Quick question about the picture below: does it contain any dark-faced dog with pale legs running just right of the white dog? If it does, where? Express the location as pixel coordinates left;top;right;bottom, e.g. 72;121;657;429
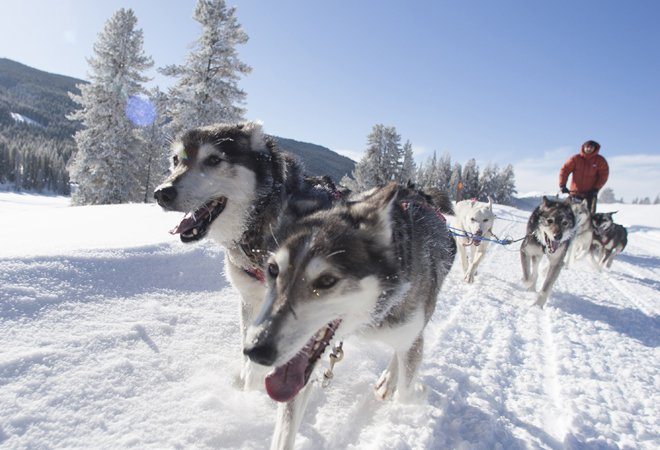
520;196;575;308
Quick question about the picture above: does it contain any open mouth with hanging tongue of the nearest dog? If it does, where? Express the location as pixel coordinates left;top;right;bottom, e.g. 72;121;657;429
266;320;341;402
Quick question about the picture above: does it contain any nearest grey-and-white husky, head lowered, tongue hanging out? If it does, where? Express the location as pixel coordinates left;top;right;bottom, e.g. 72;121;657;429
244;183;456;448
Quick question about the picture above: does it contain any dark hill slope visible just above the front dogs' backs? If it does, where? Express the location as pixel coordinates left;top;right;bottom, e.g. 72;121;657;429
273;136;355;182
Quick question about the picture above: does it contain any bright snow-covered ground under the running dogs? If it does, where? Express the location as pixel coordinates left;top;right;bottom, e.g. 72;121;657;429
0;193;660;449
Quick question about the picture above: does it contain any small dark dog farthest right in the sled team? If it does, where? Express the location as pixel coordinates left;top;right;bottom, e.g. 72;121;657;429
591;211;628;270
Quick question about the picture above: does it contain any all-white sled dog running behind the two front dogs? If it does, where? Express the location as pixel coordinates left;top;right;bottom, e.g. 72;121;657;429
454;197;495;283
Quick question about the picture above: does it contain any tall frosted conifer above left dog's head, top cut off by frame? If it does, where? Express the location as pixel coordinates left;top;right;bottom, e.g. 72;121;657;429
160;0;252;135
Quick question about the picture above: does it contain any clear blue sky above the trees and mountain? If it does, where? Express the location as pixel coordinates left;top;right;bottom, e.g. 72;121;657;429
0;0;660;201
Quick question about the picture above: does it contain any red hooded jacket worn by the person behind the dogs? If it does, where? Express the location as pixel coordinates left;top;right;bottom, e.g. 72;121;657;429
559;144;610;194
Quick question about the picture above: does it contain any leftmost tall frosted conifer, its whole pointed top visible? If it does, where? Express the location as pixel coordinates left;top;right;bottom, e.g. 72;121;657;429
68;8;153;205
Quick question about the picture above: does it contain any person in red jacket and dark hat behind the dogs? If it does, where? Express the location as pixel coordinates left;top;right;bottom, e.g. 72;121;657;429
559;141;610;214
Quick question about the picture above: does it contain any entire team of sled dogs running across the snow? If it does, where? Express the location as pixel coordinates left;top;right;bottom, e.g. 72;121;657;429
154;122;627;449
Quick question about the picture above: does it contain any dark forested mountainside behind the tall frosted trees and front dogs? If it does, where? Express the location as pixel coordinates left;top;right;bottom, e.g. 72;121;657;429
0;58;355;195
